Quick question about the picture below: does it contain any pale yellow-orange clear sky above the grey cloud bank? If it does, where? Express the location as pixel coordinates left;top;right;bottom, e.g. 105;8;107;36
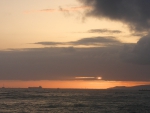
0;0;139;50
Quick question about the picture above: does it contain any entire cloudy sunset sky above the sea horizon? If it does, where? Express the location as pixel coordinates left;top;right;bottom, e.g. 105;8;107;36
0;0;150;89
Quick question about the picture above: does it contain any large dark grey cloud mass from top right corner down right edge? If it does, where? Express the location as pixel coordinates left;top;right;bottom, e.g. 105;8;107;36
79;0;150;65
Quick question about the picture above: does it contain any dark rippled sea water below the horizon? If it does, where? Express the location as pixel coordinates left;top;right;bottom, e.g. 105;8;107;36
0;89;150;113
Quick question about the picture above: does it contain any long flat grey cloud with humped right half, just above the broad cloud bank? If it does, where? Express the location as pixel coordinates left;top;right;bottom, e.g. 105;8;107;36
35;37;121;46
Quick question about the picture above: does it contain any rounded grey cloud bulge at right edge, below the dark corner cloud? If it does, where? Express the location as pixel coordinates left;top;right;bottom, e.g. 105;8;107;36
122;35;150;65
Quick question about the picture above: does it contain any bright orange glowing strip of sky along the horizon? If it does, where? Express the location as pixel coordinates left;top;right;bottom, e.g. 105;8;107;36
0;80;150;89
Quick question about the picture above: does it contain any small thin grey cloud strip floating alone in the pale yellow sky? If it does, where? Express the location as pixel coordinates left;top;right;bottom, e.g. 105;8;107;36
88;29;122;34
